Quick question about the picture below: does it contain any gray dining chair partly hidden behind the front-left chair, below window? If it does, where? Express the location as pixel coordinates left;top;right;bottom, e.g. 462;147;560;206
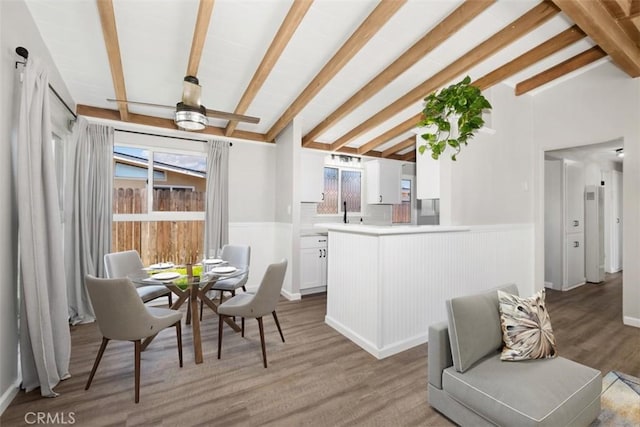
104;250;173;307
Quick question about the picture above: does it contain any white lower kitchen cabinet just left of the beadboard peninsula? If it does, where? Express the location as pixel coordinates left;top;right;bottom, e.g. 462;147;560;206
300;236;327;295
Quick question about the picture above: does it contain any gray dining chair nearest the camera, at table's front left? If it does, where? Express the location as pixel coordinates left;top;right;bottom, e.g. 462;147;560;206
84;275;182;403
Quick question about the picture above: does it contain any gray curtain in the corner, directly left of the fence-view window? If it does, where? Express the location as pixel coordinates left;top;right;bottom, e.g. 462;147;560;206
65;117;113;324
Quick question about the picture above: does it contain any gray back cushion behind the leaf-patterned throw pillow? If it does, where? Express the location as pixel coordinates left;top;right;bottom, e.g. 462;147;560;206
447;284;518;372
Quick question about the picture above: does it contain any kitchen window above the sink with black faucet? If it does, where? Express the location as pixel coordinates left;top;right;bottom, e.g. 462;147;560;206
317;167;362;214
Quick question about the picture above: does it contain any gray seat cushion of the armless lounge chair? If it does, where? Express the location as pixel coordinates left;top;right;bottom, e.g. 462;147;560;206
442;354;602;426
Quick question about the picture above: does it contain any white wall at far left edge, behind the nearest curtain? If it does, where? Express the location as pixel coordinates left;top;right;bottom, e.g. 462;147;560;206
0;0;73;413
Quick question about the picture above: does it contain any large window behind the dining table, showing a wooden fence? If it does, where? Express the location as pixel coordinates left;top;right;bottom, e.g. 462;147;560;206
112;145;207;265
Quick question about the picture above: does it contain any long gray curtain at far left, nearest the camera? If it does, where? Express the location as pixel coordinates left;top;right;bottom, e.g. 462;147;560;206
16;58;71;397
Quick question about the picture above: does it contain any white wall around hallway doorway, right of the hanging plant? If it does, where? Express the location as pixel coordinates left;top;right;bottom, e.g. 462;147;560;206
440;62;640;327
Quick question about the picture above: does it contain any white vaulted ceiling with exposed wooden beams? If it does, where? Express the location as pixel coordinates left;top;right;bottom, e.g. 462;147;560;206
25;0;640;161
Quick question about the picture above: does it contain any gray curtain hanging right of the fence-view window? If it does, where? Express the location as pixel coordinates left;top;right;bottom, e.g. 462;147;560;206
204;141;231;256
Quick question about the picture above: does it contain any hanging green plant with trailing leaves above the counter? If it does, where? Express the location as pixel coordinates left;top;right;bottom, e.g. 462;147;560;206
418;76;491;161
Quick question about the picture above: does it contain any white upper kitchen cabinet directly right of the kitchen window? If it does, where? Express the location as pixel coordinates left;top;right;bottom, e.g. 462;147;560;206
364;160;402;205
